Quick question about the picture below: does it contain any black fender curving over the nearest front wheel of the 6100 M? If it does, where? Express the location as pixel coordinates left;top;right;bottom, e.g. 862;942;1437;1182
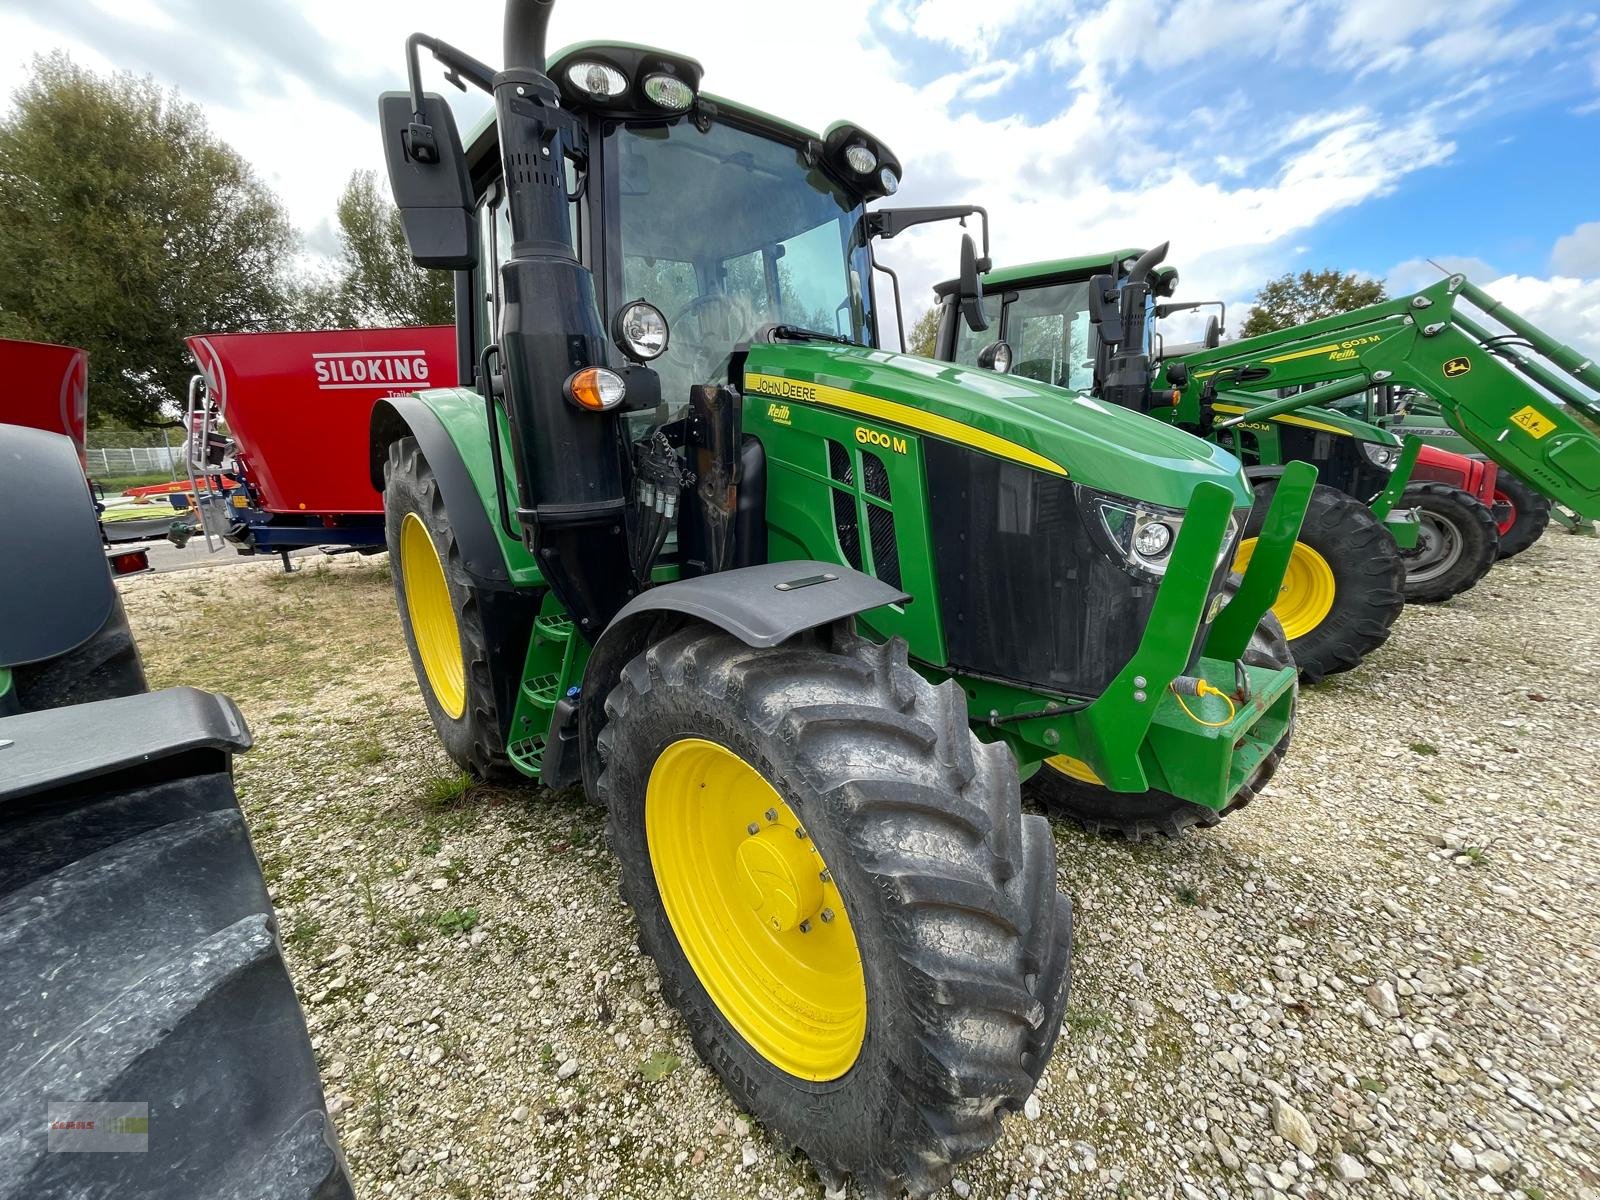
569;560;910;797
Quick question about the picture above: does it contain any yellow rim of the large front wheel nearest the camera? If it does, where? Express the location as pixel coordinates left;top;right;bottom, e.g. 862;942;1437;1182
645;738;867;1082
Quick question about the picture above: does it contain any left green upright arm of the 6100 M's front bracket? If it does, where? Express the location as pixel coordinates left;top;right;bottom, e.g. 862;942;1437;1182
1077;480;1235;792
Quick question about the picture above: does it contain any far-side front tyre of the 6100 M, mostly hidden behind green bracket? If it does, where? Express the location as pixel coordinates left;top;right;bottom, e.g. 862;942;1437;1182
1024;613;1294;842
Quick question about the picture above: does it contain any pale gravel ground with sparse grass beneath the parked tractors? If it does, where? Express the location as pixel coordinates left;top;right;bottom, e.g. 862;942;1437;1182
125;531;1600;1200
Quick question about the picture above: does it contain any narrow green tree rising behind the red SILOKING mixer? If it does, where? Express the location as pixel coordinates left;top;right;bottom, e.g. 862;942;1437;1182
294;171;456;326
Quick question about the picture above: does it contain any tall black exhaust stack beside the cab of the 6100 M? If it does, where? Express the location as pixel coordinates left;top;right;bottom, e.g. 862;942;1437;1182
494;0;634;637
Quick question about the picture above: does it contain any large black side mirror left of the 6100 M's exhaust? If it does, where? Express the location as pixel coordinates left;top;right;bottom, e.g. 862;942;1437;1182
378;91;478;270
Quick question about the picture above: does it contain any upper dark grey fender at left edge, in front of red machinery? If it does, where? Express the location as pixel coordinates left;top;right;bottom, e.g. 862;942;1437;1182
0;426;117;667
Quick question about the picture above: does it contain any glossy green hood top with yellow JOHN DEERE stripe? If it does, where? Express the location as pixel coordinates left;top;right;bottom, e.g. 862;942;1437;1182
744;342;1253;509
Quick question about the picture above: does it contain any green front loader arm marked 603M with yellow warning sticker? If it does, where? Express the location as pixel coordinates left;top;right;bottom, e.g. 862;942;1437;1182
1163;275;1600;518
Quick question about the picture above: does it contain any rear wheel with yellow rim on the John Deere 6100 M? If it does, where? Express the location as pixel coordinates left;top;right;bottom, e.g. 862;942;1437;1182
384;437;518;781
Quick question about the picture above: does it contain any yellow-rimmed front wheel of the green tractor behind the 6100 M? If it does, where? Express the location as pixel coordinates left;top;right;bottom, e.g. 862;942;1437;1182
1234;480;1405;683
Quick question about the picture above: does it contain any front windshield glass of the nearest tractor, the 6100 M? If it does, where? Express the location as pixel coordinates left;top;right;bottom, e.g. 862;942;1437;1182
618;120;872;405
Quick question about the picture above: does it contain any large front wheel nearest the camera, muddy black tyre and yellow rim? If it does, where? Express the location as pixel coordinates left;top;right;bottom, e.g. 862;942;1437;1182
597;626;1072;1197
